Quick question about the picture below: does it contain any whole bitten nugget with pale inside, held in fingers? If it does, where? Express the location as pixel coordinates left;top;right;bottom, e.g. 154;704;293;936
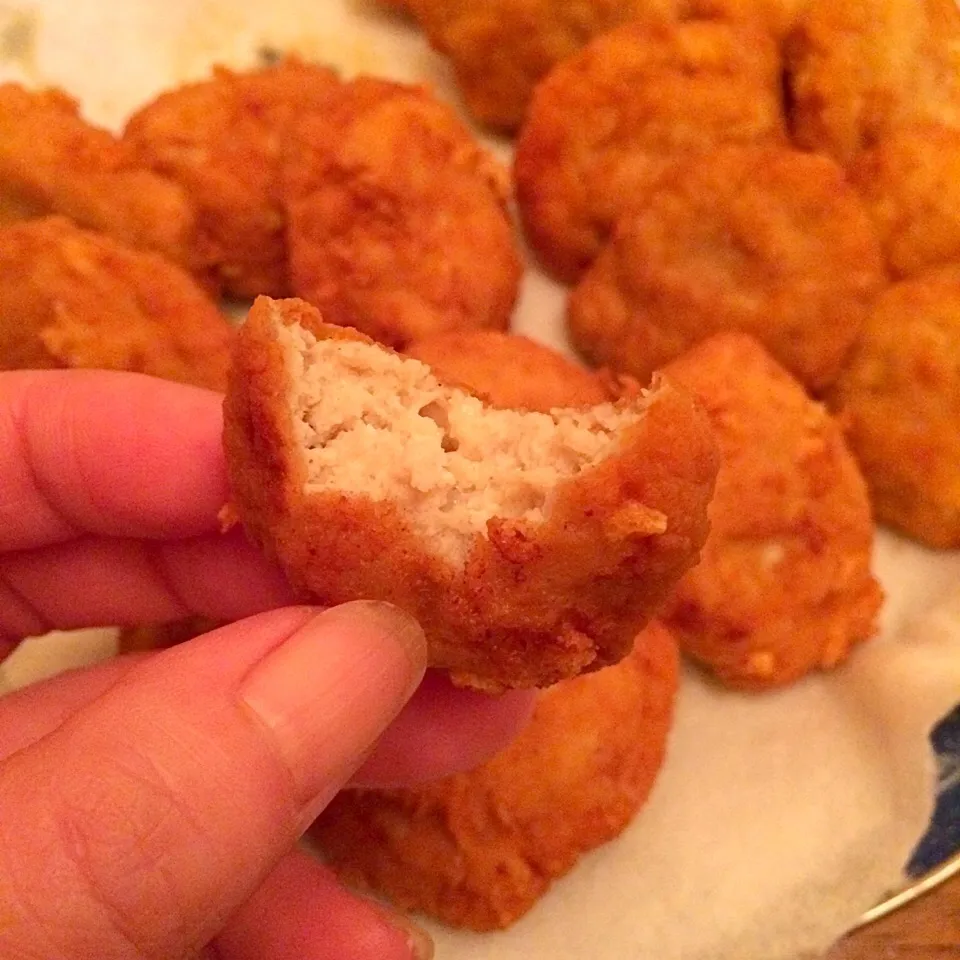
225;298;717;690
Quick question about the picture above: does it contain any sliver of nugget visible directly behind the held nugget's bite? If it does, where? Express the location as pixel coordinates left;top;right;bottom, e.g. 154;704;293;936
405;330;611;413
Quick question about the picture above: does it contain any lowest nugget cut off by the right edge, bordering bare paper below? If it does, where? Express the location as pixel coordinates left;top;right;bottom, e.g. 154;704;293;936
830;265;960;549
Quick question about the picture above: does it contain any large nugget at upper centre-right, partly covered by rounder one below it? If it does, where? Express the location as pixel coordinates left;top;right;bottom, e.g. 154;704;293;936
514;21;784;280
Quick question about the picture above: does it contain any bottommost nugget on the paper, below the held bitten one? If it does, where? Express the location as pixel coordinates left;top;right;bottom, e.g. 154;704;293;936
310;622;678;930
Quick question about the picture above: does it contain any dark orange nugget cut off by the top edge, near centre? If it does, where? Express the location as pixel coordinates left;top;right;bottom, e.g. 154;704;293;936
407;0;680;132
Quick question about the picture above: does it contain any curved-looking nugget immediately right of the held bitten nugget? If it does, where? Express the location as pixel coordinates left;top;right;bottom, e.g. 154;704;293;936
663;333;882;689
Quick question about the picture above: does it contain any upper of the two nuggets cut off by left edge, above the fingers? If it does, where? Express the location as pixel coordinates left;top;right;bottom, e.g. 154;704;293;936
0;83;194;262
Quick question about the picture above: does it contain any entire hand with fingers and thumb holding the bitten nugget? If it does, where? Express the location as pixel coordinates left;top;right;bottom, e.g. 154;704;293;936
0;371;530;960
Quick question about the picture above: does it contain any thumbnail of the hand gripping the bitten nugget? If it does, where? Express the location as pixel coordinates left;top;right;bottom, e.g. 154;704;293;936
240;601;427;827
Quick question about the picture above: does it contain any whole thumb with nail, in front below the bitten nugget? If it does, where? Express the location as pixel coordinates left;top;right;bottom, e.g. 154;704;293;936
0;603;426;960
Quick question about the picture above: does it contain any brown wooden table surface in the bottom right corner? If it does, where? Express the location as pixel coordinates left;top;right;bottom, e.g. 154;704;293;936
826;875;960;960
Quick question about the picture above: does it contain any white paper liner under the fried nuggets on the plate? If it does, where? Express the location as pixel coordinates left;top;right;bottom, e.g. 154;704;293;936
0;0;960;960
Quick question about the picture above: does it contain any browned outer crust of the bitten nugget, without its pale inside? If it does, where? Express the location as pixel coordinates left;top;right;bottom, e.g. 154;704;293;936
225;298;717;690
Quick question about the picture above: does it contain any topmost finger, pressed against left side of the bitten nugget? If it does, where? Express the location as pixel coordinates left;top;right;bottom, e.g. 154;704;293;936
0;370;228;551
